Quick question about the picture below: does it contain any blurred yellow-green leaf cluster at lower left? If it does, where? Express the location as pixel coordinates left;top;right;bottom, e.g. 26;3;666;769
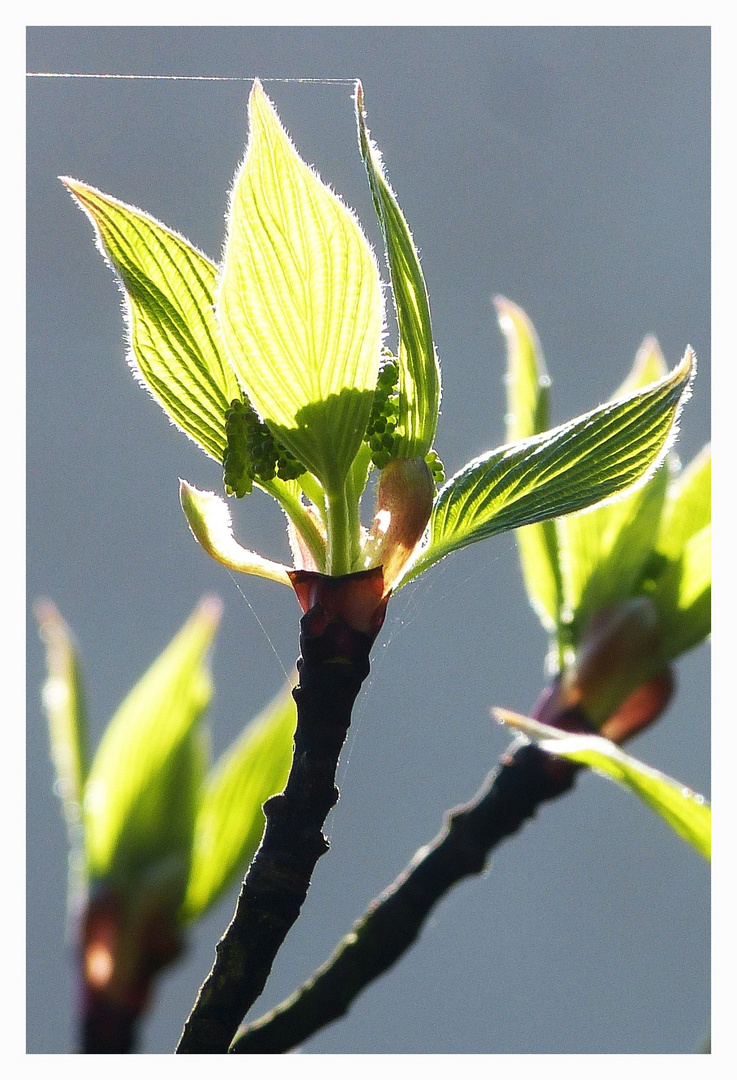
37;598;296;926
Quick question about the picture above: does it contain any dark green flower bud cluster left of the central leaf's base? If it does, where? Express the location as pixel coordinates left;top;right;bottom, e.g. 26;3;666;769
223;399;306;499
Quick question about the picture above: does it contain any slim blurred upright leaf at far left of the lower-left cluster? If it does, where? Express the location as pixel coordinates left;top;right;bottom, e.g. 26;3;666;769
36;600;88;843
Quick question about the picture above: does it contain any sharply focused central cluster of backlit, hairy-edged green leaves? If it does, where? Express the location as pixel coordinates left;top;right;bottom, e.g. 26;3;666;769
65;82;694;596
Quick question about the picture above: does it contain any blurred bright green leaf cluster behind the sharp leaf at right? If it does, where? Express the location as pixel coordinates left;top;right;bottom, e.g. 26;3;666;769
496;298;711;672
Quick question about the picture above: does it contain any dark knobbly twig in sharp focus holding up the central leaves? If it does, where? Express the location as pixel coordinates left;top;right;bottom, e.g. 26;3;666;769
176;571;386;1054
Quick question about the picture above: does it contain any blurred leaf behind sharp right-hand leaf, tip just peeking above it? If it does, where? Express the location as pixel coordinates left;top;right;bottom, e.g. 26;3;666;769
555;337;673;639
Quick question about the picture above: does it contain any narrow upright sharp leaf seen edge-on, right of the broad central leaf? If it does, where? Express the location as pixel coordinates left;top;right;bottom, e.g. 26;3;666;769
356;82;440;458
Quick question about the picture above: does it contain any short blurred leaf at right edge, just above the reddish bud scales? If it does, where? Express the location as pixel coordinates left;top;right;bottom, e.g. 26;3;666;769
651;525;711;660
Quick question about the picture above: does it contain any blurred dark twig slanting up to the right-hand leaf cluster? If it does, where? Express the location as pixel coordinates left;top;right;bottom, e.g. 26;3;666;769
230;730;585;1054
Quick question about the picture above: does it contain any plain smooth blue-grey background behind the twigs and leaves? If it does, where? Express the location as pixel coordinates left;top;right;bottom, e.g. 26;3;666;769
27;26;711;1054
